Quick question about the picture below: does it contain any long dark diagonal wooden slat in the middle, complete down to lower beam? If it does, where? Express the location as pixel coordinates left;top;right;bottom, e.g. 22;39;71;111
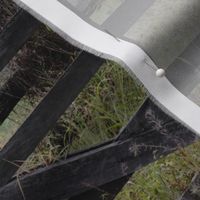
0;52;103;186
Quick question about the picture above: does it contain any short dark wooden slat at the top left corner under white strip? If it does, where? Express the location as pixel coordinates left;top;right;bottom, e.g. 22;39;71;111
0;10;40;71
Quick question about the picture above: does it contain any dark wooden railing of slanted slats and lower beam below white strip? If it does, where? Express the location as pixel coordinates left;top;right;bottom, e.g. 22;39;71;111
0;10;199;200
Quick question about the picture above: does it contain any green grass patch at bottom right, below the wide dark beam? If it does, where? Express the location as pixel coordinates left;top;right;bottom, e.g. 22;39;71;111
117;143;200;200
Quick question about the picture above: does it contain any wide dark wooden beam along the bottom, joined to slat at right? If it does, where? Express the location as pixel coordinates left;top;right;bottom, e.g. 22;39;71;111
0;100;198;200
